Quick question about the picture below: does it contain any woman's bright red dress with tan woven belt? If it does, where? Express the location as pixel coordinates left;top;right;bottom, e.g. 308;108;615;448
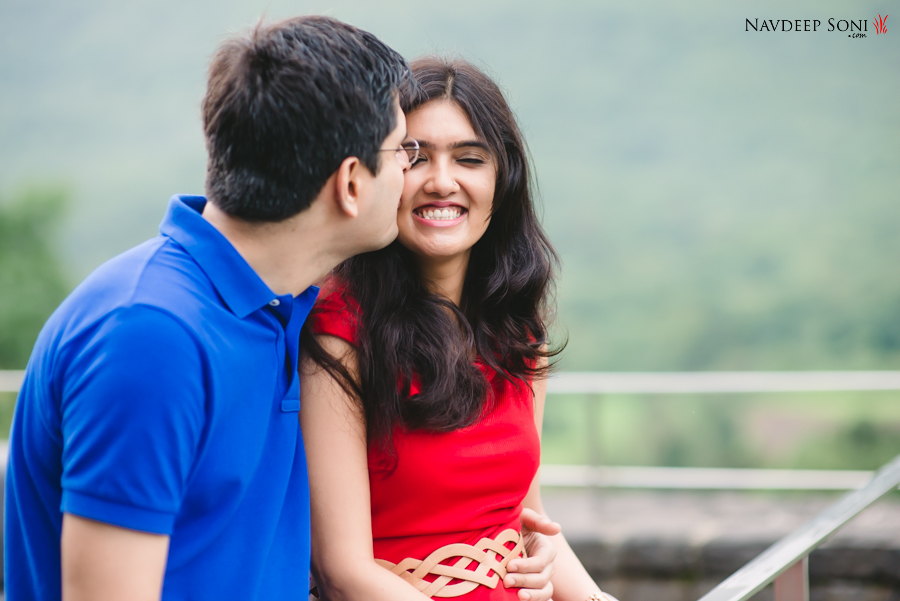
310;292;540;601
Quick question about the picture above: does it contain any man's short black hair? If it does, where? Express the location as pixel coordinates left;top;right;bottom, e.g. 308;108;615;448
203;16;410;222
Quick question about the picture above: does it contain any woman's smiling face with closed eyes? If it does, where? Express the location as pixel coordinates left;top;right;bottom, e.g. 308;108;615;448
397;99;497;270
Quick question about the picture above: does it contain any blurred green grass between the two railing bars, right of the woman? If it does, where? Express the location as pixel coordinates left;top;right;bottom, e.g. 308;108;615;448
543;391;900;470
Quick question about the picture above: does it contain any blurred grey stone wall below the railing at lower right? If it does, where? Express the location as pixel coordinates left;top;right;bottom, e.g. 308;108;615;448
544;489;900;601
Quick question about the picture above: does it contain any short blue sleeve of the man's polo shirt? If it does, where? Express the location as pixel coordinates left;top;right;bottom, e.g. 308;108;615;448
60;305;206;534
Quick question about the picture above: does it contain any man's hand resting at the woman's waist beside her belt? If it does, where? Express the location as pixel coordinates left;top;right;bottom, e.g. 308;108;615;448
503;507;560;601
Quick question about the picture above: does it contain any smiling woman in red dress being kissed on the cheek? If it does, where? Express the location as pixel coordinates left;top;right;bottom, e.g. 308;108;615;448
301;58;620;601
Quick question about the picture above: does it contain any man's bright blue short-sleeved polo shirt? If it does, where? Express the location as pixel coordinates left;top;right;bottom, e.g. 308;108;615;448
4;196;318;601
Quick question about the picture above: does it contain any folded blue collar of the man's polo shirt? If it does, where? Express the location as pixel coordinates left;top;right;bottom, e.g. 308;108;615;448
159;195;277;319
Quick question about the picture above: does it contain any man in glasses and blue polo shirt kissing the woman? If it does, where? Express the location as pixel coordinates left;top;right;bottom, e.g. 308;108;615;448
4;17;552;601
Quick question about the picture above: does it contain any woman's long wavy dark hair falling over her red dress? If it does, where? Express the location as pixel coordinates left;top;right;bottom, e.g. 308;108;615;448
303;57;559;447
